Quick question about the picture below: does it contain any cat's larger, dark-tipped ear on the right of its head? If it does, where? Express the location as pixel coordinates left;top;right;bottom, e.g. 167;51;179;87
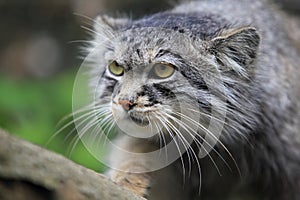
209;27;260;76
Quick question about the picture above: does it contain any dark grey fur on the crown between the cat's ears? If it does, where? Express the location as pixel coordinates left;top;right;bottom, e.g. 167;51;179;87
124;12;228;39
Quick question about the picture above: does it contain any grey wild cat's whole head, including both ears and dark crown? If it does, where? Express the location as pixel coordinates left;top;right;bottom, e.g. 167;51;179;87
85;13;259;143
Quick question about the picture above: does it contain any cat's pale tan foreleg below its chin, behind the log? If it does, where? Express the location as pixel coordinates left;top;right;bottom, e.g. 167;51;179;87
107;137;154;198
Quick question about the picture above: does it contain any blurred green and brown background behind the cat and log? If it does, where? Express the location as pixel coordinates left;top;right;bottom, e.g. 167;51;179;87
0;0;300;172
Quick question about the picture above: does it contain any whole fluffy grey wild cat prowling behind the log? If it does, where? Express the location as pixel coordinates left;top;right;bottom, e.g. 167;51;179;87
84;0;300;200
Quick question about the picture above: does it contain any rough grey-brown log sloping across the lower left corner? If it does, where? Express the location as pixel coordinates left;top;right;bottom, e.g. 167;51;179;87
0;130;141;200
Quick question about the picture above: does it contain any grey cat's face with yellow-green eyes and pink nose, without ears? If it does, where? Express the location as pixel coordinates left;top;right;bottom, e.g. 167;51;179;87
94;28;209;137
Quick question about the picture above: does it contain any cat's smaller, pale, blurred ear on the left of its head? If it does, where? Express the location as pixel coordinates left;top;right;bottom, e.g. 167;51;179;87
94;15;130;32
